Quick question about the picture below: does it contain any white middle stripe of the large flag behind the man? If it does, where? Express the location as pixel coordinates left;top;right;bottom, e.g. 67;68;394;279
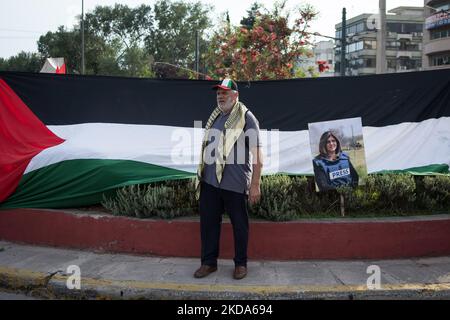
25;117;450;174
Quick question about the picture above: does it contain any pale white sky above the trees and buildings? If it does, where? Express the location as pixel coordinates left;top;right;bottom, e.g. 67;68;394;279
0;0;424;58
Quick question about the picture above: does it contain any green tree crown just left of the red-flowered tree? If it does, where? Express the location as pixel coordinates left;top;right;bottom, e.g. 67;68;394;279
146;0;211;75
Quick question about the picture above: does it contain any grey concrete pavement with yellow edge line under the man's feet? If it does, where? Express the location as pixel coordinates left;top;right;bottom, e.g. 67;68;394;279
0;241;450;299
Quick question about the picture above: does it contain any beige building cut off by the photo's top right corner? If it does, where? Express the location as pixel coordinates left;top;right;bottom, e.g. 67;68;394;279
422;0;450;69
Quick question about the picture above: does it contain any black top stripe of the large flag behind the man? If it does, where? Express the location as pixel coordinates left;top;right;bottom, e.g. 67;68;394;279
0;69;450;131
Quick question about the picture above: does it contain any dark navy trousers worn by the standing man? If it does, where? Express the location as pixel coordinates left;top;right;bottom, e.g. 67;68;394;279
200;182;248;266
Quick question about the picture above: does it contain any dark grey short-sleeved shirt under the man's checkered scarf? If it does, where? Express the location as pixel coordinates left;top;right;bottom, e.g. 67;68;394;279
202;111;261;193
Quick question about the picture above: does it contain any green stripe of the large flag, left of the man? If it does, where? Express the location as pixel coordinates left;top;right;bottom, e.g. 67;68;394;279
0;159;195;208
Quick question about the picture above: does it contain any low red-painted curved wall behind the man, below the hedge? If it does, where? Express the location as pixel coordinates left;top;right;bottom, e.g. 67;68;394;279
0;209;450;260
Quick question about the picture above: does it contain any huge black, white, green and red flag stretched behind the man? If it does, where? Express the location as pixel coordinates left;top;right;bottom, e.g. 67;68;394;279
0;70;450;208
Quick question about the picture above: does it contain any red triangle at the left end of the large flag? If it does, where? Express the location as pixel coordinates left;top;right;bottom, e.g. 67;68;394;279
0;78;64;202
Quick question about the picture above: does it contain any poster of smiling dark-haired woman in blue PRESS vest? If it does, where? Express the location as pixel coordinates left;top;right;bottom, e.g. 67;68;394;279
308;118;367;191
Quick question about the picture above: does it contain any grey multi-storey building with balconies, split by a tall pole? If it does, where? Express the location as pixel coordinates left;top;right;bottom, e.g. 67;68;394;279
335;7;424;75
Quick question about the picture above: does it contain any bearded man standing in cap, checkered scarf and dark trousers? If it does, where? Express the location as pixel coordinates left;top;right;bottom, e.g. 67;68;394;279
194;79;262;279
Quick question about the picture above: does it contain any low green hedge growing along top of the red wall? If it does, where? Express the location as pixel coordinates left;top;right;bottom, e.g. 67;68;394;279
102;174;450;221
